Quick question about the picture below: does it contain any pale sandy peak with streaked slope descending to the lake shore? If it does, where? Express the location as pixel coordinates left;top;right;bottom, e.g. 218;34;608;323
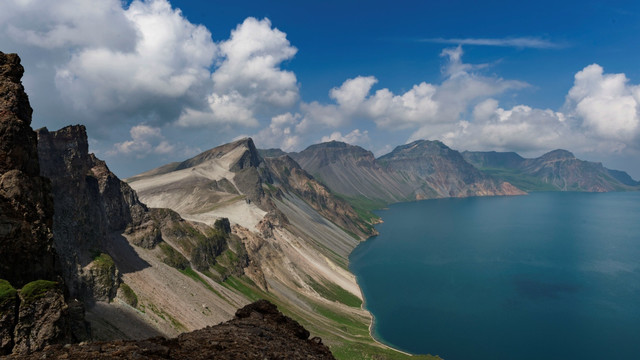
127;139;424;358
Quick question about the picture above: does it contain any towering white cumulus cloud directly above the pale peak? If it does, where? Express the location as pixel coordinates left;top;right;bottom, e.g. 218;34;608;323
178;18;299;126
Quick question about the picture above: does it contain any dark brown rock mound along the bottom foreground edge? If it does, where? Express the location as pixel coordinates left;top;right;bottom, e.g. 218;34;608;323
9;300;334;360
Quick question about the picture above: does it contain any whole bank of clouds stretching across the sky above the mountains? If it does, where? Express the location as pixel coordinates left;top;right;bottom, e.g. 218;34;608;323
0;0;640;177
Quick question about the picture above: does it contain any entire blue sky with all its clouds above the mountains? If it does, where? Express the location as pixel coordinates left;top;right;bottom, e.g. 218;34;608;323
0;0;640;179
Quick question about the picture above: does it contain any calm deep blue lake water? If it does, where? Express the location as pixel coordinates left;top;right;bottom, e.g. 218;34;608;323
351;193;640;360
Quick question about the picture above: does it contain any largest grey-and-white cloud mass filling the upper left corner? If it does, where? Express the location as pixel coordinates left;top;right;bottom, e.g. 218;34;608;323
0;0;217;129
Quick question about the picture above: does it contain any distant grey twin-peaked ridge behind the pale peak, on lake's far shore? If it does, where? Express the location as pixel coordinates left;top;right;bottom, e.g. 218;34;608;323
271;140;523;208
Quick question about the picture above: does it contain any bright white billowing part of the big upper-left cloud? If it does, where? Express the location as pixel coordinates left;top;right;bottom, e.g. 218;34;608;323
56;0;216;113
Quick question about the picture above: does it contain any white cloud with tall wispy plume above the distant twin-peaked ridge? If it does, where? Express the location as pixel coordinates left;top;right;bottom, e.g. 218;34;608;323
297;46;527;132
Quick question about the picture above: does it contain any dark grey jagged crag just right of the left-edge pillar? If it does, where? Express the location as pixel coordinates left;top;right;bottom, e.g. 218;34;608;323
37;125;148;300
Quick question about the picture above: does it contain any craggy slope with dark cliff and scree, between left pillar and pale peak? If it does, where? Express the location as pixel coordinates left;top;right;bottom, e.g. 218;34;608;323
37;125;249;339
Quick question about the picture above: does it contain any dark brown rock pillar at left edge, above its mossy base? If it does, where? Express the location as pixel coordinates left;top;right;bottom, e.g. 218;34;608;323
0;52;59;287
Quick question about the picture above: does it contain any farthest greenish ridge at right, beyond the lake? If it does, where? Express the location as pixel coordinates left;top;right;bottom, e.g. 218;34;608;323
463;150;640;192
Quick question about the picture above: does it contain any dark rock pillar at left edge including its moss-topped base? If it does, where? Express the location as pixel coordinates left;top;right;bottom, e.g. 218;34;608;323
0;52;75;355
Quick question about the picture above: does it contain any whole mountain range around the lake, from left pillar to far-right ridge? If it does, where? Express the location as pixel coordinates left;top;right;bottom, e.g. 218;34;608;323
0;53;640;359
